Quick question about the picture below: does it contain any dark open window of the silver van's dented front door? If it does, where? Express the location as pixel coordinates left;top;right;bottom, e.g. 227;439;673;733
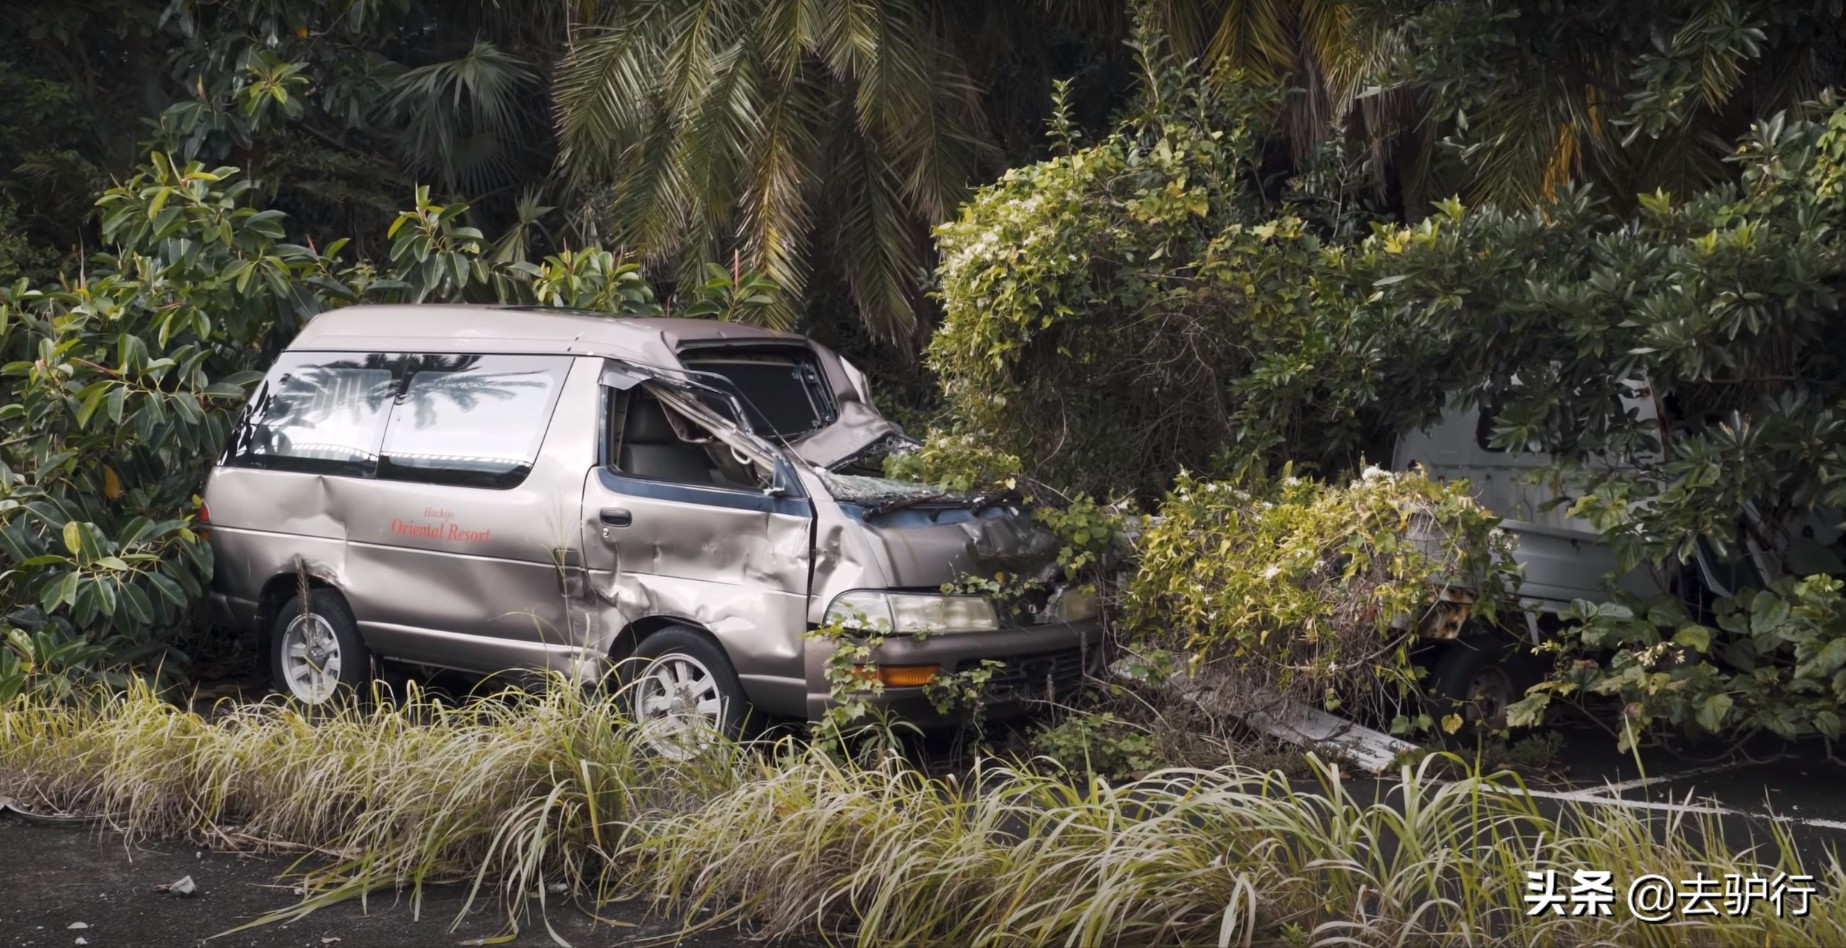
609;387;770;491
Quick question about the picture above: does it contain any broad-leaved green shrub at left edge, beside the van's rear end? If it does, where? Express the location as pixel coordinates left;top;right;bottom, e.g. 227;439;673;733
0;155;338;681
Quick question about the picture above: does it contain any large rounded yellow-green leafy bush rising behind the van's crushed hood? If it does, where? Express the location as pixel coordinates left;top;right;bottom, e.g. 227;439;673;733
929;53;1438;496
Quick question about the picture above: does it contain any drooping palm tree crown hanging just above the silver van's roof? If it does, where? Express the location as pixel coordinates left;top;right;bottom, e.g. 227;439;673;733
557;0;991;339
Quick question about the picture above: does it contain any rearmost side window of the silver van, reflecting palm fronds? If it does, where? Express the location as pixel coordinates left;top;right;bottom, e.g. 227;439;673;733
225;352;397;478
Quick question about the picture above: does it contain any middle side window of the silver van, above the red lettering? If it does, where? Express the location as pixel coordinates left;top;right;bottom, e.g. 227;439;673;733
378;354;570;489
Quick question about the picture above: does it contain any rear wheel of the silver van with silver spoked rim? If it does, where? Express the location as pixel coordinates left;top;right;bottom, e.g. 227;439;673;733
270;588;371;705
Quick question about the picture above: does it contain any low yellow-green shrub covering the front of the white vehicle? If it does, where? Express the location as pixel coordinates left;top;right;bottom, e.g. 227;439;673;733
1122;468;1514;714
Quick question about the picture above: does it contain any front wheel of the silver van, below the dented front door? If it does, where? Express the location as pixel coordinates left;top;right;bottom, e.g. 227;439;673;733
622;625;749;758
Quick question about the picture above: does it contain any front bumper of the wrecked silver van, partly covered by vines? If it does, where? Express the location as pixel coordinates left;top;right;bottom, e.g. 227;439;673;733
807;620;1104;727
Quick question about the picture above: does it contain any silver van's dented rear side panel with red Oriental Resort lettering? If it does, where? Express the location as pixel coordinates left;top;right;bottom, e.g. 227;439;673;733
205;360;600;671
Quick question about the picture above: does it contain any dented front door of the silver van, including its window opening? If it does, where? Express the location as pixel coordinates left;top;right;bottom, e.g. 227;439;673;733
583;378;814;714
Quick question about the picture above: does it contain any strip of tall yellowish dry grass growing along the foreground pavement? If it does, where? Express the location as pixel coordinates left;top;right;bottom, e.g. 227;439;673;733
0;686;1846;946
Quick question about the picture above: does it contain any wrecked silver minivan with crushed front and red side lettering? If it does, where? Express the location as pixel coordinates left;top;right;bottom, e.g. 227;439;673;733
205;304;1102;732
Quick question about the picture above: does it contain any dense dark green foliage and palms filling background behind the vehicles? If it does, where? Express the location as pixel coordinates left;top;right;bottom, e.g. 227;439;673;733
0;0;1846;748
